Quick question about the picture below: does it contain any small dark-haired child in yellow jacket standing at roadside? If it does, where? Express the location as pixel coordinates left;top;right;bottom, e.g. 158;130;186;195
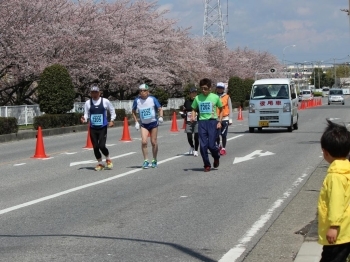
317;120;350;262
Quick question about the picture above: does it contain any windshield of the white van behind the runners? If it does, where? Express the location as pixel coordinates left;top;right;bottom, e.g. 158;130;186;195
251;84;289;100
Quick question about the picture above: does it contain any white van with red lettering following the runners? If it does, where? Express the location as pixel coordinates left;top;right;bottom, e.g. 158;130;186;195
248;78;299;133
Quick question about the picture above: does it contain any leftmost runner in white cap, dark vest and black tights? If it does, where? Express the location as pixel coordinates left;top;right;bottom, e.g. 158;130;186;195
81;85;116;171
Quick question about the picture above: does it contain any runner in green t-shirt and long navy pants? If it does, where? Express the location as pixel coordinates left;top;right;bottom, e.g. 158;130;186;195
192;78;222;172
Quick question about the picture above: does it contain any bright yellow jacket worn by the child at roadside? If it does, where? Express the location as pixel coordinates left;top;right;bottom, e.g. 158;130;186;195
317;160;350;245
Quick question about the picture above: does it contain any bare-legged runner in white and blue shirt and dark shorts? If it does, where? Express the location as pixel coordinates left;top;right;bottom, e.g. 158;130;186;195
132;84;163;169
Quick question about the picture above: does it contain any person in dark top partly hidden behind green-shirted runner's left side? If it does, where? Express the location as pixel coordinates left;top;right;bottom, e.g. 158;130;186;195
181;87;199;157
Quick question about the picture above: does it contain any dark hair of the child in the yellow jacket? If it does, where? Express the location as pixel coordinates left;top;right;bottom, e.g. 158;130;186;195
321;119;350;157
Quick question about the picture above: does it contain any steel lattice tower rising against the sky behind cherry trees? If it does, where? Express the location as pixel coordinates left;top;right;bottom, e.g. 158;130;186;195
203;0;228;46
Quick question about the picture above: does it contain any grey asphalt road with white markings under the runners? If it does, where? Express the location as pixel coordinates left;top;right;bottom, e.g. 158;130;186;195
0;99;350;262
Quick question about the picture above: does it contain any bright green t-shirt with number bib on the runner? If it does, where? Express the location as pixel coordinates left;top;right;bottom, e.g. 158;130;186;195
191;93;222;120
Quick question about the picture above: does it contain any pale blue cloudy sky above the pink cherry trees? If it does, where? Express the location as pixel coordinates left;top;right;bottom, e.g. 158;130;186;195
157;0;350;64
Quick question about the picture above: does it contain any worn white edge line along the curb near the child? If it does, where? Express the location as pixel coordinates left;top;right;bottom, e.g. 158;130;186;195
219;174;307;262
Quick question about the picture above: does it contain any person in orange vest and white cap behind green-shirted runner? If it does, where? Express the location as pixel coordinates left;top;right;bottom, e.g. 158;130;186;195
216;82;233;156
